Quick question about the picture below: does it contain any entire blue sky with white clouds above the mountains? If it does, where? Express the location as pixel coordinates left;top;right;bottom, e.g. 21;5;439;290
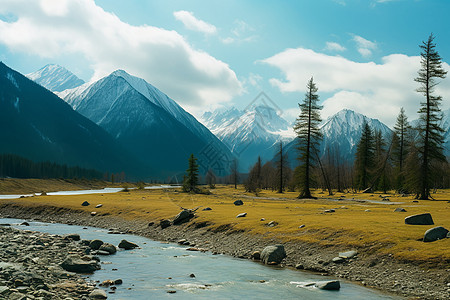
0;0;450;126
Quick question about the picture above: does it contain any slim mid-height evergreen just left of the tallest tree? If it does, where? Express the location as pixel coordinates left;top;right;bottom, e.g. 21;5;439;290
392;107;411;191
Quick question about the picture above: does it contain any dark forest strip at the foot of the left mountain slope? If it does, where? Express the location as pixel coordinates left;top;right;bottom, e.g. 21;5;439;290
0;154;103;179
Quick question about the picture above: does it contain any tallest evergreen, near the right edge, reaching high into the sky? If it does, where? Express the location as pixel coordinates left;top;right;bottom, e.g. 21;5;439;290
414;34;447;200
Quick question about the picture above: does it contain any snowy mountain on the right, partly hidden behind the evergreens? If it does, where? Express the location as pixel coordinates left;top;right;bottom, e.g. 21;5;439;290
286;109;392;167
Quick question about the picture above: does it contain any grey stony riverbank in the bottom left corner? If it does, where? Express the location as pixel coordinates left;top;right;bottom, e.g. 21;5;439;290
0;225;98;300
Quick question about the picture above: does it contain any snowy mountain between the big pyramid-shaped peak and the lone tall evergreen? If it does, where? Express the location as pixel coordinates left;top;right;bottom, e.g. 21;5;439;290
201;105;295;172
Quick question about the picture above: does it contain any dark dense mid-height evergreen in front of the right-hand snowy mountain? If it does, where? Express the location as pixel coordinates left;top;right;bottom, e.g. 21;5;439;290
355;121;375;190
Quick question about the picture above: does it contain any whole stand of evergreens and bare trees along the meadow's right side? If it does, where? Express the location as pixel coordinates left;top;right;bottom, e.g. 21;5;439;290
244;34;450;199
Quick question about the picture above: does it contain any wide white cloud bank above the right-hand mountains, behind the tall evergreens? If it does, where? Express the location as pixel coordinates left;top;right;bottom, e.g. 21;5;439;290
263;48;450;126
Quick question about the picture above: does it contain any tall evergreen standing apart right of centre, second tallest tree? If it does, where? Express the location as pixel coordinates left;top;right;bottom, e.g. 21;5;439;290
294;77;322;199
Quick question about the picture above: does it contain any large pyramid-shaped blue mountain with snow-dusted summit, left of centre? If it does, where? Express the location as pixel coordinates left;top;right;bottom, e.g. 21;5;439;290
58;70;232;176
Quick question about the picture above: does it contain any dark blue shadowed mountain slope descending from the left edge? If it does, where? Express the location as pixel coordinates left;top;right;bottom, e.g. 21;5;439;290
0;63;141;174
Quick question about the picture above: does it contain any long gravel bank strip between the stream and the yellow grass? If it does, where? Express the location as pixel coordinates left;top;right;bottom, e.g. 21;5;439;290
0;203;450;299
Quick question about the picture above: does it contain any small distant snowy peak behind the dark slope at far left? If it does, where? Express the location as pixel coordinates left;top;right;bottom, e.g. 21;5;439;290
26;64;84;92
